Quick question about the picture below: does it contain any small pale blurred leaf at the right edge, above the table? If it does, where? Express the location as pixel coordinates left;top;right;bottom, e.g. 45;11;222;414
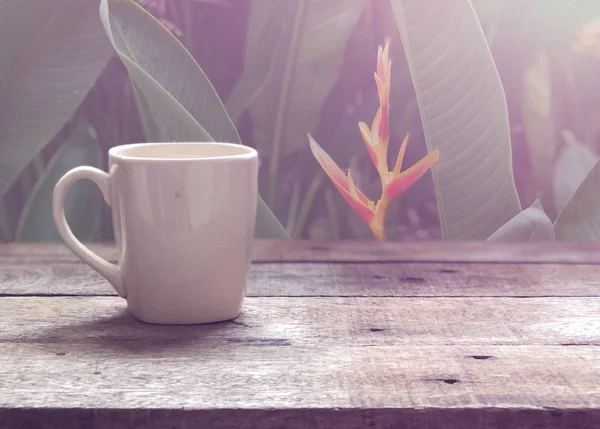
553;131;600;213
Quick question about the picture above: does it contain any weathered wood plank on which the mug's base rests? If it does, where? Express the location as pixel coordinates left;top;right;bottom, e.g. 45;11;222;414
0;297;600;348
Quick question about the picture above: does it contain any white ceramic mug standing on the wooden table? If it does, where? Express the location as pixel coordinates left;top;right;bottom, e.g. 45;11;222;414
53;142;258;324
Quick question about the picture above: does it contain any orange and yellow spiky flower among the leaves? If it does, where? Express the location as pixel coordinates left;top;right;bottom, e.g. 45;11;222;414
308;41;439;240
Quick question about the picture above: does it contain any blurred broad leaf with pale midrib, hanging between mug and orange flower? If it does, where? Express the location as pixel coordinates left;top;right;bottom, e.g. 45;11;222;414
228;0;365;203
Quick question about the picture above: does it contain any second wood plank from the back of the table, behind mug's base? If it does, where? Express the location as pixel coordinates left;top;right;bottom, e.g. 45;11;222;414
0;262;600;296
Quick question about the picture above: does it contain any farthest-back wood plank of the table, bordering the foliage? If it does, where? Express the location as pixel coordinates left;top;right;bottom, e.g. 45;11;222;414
0;240;600;265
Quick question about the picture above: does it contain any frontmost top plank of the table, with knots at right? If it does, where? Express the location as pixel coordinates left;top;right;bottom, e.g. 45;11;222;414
0;342;600;406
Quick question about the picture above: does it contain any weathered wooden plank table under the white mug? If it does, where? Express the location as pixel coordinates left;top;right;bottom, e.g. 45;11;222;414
0;241;600;429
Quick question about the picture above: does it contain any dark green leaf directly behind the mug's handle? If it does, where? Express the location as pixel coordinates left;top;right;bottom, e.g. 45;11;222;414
17;123;103;242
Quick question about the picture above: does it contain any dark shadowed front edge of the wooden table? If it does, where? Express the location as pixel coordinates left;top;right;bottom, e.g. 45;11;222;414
0;407;600;429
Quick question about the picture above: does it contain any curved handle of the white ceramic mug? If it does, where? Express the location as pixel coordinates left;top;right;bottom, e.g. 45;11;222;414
52;166;126;298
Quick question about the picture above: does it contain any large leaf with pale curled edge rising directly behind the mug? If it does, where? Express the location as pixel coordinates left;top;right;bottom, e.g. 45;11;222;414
100;0;287;237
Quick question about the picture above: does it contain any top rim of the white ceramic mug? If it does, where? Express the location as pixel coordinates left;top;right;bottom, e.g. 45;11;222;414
108;141;258;162
